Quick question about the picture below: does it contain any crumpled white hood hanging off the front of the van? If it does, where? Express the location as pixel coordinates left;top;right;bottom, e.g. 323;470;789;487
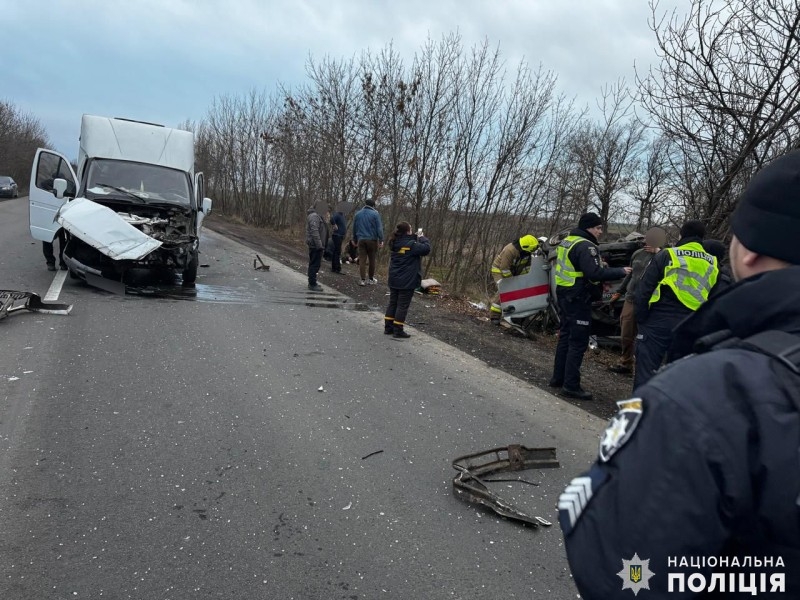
56;198;161;260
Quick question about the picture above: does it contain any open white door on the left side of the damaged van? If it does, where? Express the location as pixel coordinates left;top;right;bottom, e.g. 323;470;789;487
28;148;78;242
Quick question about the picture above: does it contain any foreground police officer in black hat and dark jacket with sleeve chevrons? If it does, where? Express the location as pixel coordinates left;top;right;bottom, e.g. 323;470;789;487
558;151;800;600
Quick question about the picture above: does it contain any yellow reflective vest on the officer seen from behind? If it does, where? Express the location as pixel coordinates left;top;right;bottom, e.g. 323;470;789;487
649;242;719;311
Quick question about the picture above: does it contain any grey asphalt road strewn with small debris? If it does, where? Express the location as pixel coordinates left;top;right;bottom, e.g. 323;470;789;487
0;198;604;600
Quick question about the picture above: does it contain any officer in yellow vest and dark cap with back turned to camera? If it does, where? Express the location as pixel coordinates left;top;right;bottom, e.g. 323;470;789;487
633;221;719;390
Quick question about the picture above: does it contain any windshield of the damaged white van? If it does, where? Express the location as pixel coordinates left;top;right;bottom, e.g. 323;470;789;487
86;159;190;205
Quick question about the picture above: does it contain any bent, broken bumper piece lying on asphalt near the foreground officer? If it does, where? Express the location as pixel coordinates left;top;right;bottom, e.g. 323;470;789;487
453;444;560;527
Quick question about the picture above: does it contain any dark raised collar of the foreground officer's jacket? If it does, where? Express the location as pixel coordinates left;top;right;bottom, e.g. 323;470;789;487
670;266;800;356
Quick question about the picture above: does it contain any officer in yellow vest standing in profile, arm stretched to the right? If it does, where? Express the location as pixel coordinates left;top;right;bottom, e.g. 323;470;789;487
550;213;631;400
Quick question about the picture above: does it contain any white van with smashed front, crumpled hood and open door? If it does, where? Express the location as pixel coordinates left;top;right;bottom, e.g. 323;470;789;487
30;115;211;290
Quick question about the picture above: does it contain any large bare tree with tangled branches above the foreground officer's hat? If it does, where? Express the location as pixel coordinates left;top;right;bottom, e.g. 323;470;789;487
637;0;800;235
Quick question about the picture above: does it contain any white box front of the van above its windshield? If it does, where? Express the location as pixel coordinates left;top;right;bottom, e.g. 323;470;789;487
78;115;194;176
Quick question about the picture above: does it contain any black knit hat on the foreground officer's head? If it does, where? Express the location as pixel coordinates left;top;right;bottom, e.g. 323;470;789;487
731;150;800;265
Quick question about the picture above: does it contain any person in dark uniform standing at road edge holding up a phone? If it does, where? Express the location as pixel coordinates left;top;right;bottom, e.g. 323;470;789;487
383;221;431;339
